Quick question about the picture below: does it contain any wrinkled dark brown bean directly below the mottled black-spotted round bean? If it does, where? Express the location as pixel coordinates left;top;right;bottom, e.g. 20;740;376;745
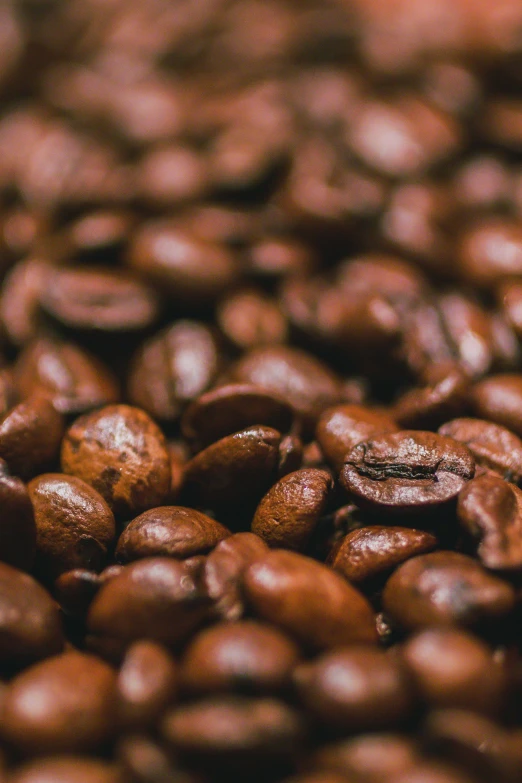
28;473;116;579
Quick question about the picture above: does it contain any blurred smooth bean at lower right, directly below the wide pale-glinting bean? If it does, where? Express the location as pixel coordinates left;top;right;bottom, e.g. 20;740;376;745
400;628;506;713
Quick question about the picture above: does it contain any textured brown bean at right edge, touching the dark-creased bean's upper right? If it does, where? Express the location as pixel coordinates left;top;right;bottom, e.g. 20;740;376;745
439;419;522;484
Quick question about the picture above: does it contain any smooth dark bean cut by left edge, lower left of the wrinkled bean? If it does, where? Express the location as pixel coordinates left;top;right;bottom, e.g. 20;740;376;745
0;563;64;668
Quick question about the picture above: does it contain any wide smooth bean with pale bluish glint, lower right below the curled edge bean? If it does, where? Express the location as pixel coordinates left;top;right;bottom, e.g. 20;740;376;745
382;552;514;630
